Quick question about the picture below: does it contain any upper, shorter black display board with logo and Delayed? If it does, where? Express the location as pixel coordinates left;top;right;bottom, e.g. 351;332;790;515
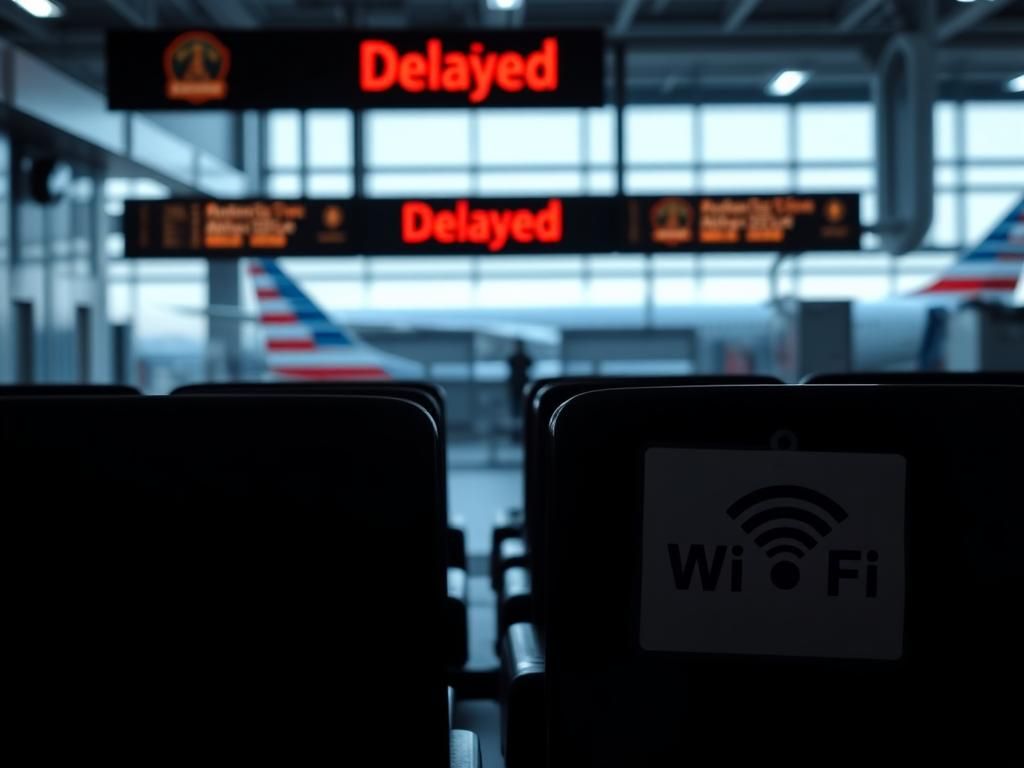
106;29;604;110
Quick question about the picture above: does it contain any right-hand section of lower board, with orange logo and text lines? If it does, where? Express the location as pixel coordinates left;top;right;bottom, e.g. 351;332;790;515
622;195;861;252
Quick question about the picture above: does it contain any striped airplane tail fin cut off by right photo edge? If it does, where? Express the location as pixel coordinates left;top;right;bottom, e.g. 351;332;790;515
918;200;1024;299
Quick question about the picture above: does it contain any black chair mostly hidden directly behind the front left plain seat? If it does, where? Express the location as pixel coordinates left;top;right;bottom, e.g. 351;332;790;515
171;380;469;668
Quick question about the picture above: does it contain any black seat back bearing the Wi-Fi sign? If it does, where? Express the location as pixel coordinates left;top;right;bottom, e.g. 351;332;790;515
539;386;1024;768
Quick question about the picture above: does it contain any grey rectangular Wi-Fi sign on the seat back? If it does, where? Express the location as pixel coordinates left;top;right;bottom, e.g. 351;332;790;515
640;449;906;660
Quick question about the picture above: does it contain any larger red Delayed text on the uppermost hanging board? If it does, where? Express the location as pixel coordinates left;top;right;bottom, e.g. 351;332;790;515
359;37;558;104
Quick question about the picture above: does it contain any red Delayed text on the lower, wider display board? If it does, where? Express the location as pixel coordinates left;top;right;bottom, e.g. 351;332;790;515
401;200;564;253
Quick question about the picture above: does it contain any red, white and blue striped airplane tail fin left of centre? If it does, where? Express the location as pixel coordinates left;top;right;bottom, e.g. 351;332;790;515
249;258;390;380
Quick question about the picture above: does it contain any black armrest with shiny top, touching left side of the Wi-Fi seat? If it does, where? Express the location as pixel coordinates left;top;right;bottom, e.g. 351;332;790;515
501;623;547;768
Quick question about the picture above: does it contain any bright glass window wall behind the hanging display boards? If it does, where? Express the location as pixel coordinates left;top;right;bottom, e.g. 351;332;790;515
104;99;1024;382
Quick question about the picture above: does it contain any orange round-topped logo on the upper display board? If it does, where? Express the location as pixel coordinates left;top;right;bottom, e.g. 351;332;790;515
164;32;231;104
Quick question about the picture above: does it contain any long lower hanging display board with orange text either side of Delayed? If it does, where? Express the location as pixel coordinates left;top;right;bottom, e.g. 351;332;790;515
124;194;861;258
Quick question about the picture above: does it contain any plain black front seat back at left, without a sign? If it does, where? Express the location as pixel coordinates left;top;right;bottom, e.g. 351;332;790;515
0;395;476;766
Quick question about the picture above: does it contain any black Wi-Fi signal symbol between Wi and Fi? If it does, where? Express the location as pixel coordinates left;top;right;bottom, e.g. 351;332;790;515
726;485;848;590
